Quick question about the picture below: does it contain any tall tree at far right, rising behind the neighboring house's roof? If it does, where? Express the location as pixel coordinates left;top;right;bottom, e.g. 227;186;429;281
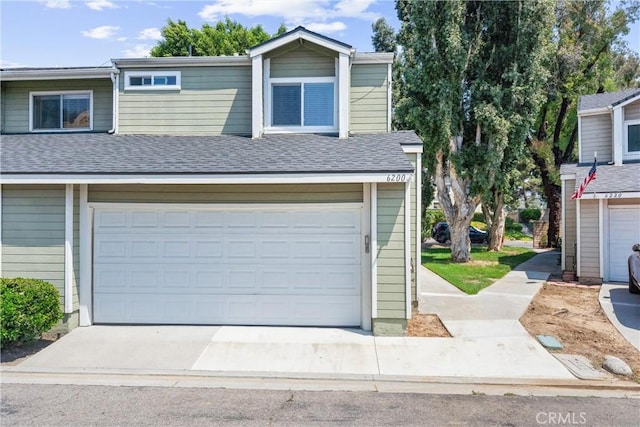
527;0;640;246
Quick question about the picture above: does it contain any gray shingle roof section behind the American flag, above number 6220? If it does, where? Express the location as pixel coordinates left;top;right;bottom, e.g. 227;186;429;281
560;163;640;193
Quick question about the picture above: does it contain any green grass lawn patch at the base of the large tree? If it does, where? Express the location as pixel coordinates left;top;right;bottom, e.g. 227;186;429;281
422;246;536;295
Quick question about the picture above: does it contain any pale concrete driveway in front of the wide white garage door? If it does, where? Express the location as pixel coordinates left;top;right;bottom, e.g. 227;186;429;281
3;326;575;380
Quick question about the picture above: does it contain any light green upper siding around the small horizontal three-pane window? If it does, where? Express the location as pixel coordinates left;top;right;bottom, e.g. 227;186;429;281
118;66;251;135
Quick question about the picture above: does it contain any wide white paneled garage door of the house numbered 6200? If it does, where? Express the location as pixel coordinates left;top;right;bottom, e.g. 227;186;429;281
93;204;362;326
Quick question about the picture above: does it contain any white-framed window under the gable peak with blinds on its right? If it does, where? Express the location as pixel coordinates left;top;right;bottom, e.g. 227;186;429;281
267;77;337;132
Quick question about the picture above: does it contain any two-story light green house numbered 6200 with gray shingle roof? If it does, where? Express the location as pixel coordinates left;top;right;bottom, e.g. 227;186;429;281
0;27;422;335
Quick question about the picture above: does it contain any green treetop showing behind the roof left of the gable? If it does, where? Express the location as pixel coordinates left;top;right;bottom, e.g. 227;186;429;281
151;17;286;57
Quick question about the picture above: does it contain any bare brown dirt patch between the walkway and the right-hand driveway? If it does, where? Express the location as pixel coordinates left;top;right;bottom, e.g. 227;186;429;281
520;282;640;382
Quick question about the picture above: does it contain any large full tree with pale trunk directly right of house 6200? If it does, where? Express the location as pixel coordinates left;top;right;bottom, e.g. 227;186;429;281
396;0;553;262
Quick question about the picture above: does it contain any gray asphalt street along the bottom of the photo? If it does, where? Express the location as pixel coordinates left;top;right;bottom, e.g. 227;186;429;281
1;384;640;427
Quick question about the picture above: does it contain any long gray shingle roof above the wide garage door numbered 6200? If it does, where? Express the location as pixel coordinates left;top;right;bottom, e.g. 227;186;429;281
0;132;421;175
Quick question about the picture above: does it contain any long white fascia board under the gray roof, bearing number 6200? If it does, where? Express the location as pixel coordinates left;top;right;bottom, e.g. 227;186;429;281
0;171;413;184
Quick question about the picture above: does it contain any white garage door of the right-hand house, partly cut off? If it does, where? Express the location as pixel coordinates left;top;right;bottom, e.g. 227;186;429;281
609;205;640;282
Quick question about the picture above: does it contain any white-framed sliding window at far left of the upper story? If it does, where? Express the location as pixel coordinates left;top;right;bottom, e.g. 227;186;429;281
29;91;93;132
